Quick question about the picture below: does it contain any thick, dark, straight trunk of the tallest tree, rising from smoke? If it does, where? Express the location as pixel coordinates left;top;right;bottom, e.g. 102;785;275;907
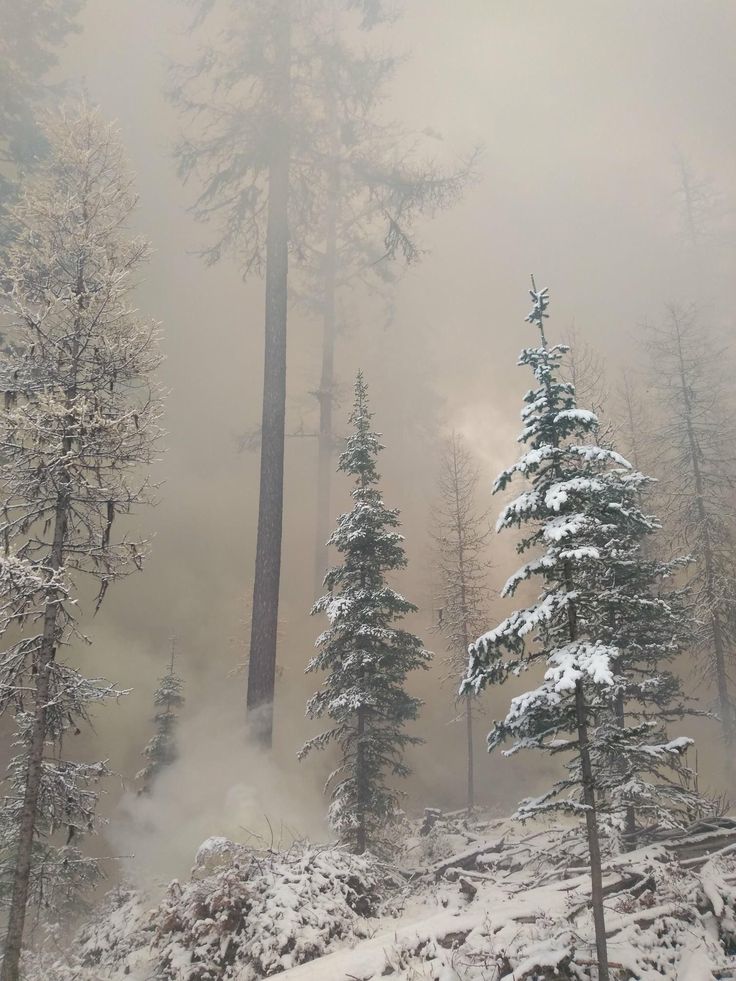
247;0;291;748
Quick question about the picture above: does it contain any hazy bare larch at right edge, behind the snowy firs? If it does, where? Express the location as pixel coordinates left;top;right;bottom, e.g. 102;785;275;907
646;306;736;748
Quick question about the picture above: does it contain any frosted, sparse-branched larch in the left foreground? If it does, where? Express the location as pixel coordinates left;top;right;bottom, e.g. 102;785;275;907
0;106;161;981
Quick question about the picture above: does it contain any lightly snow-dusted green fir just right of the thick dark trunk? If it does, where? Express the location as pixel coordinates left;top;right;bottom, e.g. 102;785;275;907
300;374;431;854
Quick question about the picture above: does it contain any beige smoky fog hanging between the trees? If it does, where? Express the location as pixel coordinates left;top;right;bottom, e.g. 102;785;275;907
49;0;736;875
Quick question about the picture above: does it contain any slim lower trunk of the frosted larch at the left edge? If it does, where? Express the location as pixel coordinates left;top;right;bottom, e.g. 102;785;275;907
0;494;68;981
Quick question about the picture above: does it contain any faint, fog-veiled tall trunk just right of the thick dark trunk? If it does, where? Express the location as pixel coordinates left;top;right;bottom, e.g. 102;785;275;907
314;129;340;596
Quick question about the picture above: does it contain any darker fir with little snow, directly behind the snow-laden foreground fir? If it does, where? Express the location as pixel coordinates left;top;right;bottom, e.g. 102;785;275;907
589;482;707;848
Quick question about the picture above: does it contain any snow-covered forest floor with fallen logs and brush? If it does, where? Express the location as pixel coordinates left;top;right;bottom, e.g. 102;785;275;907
28;811;736;981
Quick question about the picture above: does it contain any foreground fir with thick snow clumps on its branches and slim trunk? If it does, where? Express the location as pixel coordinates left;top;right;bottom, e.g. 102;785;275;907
461;281;690;979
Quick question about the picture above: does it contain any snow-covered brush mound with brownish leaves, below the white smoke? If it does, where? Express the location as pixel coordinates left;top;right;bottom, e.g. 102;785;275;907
30;839;392;981
